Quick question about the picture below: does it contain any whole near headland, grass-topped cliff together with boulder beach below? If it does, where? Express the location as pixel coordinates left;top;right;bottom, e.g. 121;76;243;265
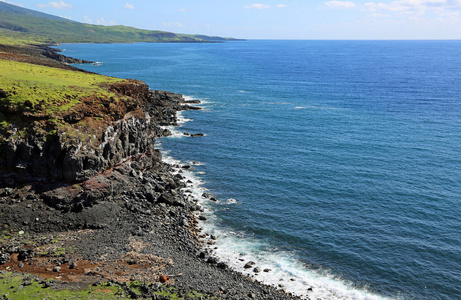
0;48;292;299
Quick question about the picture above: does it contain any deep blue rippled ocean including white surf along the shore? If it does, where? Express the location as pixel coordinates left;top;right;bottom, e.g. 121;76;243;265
59;40;461;299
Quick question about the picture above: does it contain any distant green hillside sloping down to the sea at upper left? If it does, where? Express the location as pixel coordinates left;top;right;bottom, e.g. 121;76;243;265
0;2;237;44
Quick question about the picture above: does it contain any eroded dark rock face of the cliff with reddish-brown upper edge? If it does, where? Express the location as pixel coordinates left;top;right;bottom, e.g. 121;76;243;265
0;80;188;186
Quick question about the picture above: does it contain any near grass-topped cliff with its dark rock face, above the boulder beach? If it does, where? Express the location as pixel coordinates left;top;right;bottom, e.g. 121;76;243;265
0;48;186;186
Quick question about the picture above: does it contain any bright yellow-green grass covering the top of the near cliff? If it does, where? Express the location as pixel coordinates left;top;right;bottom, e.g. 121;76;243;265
0;60;127;139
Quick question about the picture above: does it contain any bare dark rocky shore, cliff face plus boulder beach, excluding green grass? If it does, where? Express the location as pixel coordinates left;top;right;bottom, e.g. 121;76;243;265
0;45;295;299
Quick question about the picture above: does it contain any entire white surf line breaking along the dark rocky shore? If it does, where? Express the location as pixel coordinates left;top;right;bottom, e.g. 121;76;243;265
156;96;388;300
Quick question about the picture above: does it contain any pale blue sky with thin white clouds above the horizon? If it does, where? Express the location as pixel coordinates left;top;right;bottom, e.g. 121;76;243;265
0;0;461;40
